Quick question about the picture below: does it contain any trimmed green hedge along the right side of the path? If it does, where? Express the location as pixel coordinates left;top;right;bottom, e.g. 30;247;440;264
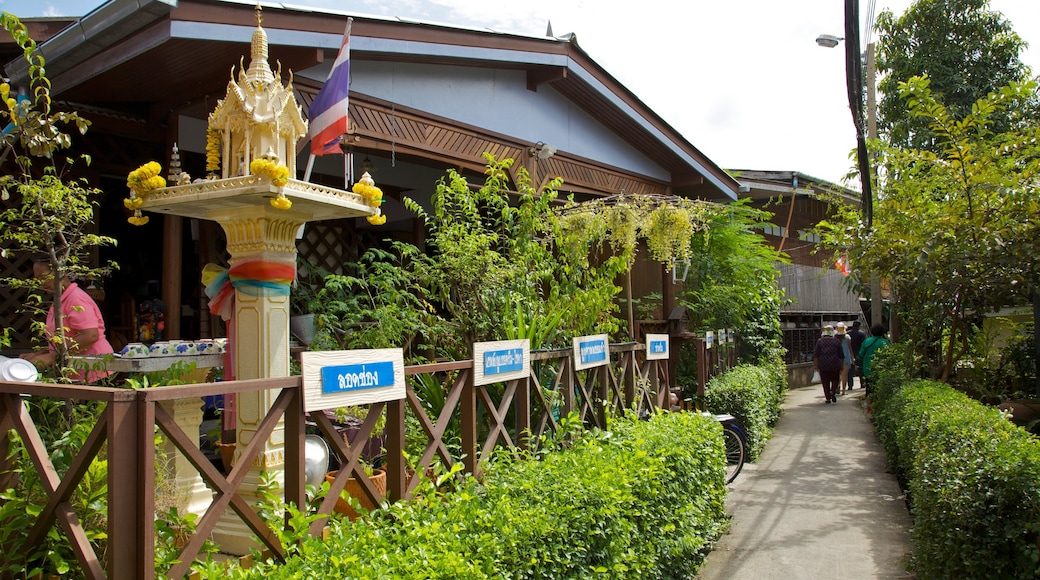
873;374;1040;579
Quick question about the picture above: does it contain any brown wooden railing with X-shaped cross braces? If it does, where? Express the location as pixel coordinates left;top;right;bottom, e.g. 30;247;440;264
0;344;669;579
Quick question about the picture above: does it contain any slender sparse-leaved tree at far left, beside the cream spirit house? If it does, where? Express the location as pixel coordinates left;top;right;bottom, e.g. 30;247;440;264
0;12;115;376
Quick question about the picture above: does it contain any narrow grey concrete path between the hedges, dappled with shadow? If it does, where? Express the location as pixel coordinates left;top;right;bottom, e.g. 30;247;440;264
696;381;914;580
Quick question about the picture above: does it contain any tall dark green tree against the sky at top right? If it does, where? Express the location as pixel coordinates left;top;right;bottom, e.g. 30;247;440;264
877;0;1040;153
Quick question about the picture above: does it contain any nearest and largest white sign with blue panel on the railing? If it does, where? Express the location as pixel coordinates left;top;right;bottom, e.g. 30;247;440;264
300;348;405;413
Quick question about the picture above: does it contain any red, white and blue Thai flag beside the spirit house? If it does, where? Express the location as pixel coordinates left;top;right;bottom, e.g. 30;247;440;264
309;18;354;155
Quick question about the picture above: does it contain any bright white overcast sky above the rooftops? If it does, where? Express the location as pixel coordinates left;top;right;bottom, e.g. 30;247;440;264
6;0;1040;188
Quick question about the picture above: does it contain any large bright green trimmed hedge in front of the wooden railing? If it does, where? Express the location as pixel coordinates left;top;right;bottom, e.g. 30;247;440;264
211;413;726;580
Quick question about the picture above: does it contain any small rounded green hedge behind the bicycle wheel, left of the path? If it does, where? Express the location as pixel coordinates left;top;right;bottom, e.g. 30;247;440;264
704;365;787;462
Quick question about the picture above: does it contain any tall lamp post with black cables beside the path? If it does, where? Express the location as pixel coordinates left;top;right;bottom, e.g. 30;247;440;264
816;0;884;325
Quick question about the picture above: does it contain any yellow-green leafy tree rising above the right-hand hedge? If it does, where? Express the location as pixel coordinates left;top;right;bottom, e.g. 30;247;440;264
821;78;1040;380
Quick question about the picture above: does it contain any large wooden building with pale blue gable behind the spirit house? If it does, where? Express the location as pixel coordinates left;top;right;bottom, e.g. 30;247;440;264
0;0;738;349
